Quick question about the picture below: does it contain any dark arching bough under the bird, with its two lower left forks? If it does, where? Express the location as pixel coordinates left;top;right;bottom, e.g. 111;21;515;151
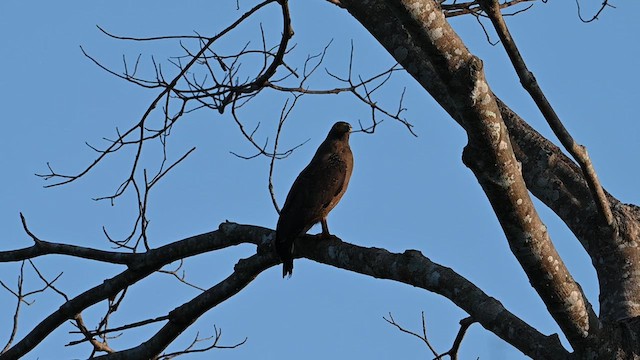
0;222;568;359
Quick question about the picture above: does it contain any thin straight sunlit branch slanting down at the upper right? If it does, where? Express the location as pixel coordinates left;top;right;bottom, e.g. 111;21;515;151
479;0;615;228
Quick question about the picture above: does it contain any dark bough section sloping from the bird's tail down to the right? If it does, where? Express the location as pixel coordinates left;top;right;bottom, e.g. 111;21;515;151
296;232;568;359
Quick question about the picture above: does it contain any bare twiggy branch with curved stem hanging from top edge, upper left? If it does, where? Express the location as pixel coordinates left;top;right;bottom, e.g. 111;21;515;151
38;0;284;201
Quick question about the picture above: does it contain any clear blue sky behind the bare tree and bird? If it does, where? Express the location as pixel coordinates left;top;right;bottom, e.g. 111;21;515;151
0;0;640;359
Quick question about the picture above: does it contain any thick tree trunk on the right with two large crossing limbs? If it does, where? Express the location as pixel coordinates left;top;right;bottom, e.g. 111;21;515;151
341;0;640;359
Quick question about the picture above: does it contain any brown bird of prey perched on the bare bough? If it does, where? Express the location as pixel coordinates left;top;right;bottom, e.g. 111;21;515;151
276;121;353;277
